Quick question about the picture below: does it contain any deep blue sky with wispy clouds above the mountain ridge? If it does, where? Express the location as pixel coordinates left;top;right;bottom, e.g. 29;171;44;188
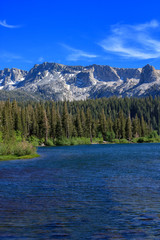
0;0;160;70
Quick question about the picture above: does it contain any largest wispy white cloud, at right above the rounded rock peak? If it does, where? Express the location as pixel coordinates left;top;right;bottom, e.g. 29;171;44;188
99;20;160;59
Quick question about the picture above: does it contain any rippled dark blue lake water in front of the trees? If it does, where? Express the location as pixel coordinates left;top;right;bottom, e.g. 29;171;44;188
0;144;160;240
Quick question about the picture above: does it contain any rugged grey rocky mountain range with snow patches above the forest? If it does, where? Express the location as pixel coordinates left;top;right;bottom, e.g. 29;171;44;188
0;62;160;100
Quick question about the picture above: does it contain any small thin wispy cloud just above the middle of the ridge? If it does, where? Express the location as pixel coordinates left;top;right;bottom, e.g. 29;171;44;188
60;44;98;61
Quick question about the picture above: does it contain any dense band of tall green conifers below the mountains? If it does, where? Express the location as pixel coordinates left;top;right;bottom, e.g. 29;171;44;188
0;97;160;144
